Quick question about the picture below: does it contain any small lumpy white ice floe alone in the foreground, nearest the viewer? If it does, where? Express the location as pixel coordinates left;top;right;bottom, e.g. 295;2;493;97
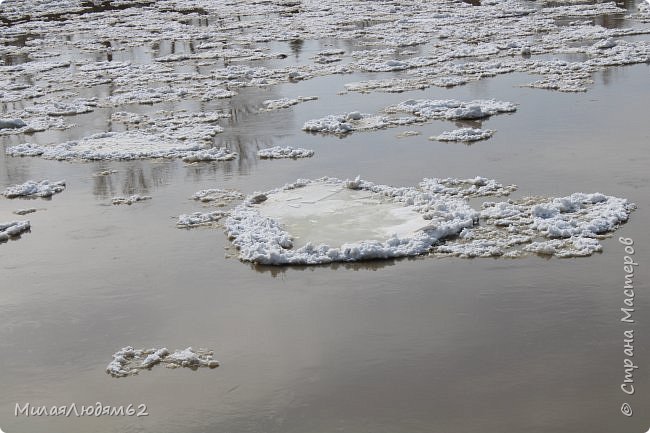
106;346;219;377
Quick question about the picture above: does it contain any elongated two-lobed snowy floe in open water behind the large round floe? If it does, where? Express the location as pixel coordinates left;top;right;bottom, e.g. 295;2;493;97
302;99;517;135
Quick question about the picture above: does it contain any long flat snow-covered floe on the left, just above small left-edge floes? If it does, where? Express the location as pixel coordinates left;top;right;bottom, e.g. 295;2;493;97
6;131;236;162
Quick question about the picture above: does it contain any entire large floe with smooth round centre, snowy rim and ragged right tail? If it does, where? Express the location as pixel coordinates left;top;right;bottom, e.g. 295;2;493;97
225;177;635;265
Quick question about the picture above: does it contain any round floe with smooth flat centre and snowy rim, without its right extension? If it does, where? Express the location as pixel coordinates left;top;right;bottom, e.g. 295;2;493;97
225;178;509;265
